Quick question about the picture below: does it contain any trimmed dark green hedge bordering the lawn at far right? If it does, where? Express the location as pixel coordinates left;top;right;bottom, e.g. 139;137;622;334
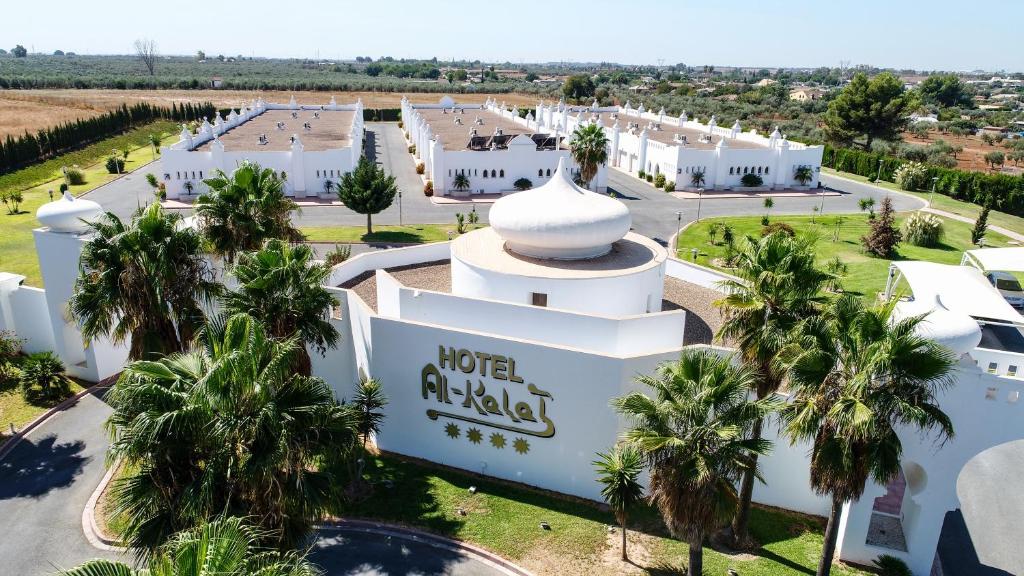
821;145;1024;216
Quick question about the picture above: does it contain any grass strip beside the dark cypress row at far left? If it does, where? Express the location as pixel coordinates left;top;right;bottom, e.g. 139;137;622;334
0;122;176;287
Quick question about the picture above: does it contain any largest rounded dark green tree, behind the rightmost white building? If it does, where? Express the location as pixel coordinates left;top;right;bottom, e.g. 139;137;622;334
824;72;918;150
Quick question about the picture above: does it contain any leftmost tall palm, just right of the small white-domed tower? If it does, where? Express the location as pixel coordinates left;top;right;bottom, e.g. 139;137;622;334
69;202;220;360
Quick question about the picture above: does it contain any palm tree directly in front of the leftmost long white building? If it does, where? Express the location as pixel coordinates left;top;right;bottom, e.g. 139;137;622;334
196;161;303;263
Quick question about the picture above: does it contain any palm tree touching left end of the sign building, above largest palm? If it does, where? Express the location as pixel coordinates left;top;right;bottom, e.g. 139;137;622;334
224;240;338;376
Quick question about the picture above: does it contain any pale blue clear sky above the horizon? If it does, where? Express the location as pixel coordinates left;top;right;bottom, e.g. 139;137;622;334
0;0;1024;72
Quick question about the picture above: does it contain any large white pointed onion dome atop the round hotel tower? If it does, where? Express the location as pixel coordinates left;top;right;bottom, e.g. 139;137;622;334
487;158;632;259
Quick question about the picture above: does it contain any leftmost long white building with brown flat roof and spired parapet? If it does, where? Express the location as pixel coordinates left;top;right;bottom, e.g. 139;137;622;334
160;97;362;199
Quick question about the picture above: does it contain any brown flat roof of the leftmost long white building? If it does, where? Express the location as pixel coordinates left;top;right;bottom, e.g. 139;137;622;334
196;110;355;152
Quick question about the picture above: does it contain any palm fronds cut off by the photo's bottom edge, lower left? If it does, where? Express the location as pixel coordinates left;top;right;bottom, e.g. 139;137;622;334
60;518;321;576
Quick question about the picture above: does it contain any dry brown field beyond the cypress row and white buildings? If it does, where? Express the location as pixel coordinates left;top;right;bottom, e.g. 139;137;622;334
0;89;538;138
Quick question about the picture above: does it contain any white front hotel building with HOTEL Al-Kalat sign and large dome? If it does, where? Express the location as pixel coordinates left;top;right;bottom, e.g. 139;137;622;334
0;168;1024;576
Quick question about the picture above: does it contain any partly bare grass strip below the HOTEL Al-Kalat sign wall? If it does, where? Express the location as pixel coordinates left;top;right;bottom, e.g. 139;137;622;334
97;455;867;576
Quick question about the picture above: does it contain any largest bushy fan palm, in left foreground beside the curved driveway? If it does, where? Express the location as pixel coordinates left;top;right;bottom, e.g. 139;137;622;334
106;315;358;554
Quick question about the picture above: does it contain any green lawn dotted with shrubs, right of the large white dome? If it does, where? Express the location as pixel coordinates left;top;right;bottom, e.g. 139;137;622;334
678;214;1009;296
